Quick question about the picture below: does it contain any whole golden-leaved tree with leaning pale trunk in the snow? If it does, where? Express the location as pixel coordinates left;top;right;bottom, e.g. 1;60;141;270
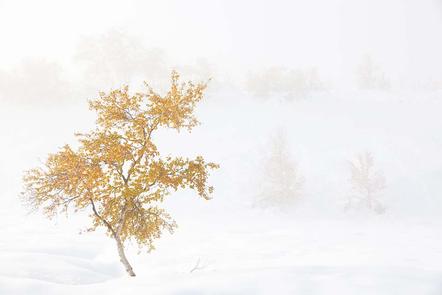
23;72;218;276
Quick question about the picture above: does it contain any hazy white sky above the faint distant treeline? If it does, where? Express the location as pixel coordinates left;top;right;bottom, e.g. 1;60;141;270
0;0;442;103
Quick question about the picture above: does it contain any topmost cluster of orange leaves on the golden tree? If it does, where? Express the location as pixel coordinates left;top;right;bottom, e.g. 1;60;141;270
89;71;207;137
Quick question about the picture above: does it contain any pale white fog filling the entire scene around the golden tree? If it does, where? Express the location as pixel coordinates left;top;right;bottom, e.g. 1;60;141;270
0;0;442;294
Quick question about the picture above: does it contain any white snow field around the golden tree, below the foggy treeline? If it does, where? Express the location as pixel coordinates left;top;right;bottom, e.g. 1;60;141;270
0;90;442;295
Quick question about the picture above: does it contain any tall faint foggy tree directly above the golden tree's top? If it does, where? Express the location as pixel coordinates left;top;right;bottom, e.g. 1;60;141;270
74;29;169;91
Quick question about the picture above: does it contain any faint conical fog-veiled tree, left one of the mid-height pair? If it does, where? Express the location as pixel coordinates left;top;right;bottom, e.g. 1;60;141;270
255;132;304;209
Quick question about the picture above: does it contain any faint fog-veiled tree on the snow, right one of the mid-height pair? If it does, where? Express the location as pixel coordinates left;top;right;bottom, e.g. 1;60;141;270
345;152;385;213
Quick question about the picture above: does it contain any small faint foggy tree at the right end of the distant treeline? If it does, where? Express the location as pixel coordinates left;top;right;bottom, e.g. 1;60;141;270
356;55;390;90
